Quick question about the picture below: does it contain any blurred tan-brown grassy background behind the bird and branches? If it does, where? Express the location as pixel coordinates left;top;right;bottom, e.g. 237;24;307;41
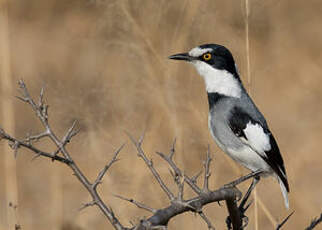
0;0;322;230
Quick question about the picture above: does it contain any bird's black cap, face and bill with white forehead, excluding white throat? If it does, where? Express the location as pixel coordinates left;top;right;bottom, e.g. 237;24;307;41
169;44;238;76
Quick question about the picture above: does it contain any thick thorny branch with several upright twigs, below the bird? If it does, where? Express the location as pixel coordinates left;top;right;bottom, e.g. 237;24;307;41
129;135;242;229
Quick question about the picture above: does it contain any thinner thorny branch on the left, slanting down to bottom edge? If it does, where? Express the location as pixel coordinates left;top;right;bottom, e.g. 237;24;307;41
0;80;125;230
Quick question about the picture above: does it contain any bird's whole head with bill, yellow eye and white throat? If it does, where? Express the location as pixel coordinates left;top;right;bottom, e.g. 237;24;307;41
169;44;242;97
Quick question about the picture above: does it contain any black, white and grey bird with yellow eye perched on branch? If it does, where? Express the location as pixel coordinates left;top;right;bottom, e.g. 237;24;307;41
169;44;290;209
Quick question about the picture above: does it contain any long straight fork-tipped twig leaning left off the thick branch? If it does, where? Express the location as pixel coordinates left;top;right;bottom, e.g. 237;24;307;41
127;133;175;201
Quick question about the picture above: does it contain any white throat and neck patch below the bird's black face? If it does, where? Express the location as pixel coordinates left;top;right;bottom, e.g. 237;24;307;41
191;61;242;98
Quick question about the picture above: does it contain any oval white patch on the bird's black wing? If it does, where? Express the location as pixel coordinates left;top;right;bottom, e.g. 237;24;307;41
243;122;271;156
